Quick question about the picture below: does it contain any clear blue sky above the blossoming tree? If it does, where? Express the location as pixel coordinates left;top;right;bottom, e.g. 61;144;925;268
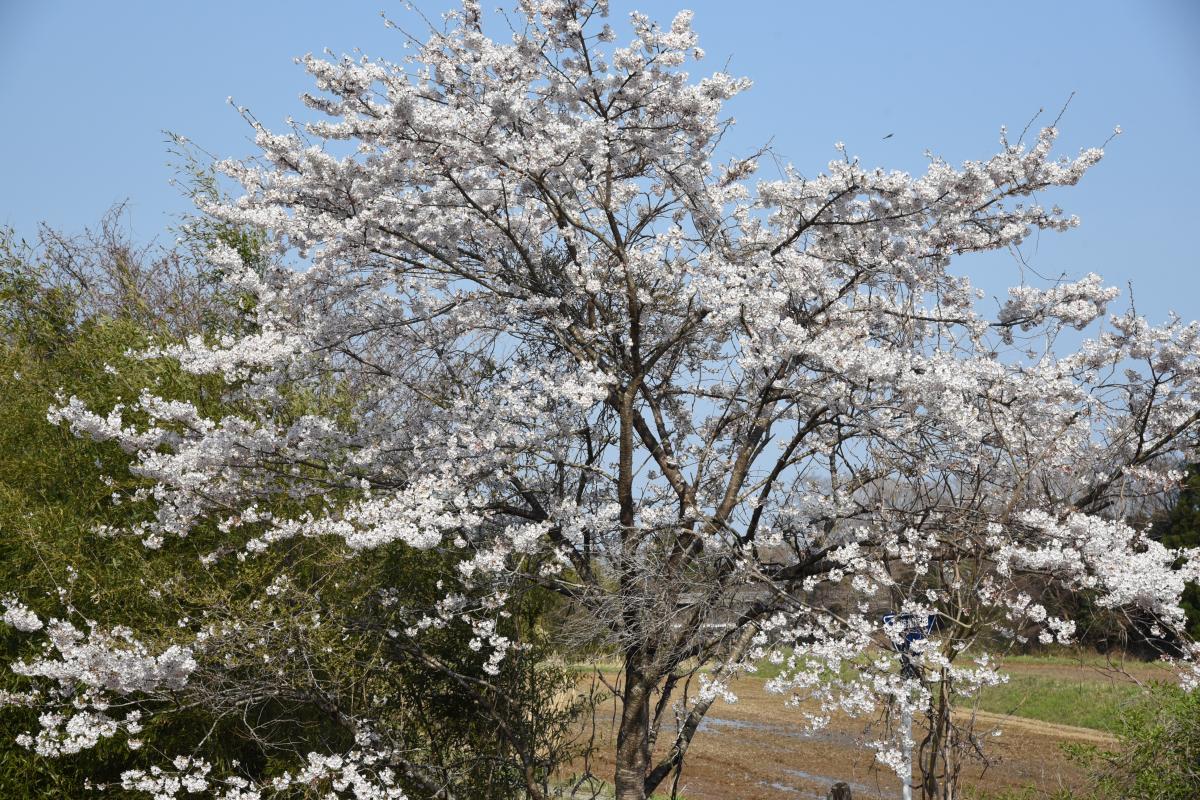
0;0;1200;321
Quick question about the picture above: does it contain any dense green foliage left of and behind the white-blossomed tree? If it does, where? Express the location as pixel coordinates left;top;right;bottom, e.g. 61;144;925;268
0;225;588;800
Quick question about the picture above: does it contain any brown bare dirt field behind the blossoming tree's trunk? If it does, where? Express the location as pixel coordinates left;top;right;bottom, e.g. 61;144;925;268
566;664;1137;800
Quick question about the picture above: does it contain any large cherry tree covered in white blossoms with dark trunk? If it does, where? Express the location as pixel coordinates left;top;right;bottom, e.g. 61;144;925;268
5;0;1200;800
